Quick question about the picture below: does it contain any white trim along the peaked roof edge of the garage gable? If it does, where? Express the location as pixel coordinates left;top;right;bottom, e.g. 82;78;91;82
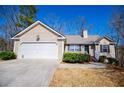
11;21;65;39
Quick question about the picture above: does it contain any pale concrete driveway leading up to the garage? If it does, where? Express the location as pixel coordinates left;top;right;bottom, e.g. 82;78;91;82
0;60;58;87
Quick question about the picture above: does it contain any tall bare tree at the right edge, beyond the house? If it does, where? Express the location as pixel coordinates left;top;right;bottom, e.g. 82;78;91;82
111;6;124;66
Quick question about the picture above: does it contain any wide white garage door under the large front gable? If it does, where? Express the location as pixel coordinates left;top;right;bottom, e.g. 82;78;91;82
19;43;58;59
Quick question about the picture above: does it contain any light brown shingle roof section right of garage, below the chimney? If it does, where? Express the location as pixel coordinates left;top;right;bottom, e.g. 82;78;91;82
65;35;100;44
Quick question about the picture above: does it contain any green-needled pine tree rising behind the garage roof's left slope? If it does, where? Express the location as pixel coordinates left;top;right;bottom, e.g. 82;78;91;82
16;5;38;29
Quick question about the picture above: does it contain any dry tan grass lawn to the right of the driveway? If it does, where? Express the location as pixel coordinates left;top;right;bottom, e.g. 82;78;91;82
49;68;124;87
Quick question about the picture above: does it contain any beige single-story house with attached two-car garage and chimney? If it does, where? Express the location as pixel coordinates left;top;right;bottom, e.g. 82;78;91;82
12;21;115;60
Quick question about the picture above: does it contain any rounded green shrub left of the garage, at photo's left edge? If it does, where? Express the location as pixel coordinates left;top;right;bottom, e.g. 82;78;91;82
0;51;16;60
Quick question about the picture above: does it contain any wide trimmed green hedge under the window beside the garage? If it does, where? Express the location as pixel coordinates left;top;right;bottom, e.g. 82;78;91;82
63;52;90;63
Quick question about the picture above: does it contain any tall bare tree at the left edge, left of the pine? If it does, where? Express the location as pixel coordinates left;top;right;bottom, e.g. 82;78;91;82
0;6;19;50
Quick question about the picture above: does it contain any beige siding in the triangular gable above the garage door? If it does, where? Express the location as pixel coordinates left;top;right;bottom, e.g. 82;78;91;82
20;24;58;42
